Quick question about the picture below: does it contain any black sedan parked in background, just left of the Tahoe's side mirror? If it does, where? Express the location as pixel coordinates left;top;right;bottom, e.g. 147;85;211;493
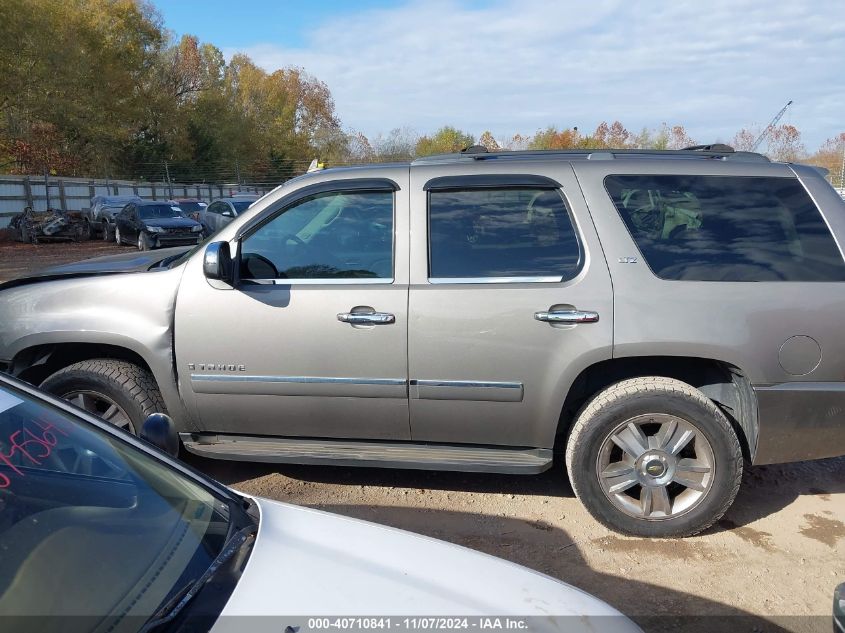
114;202;202;251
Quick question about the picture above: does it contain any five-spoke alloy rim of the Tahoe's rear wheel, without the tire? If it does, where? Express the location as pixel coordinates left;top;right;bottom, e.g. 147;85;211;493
596;413;716;521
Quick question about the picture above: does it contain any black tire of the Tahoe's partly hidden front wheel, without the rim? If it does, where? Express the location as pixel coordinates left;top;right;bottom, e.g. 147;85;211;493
41;358;167;435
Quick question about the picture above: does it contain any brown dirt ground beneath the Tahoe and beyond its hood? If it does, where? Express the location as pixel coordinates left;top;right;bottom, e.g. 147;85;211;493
0;242;845;633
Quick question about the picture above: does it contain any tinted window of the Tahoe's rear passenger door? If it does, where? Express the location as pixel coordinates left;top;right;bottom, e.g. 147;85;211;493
428;187;580;279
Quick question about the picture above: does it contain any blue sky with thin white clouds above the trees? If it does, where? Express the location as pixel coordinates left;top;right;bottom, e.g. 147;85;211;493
154;0;845;151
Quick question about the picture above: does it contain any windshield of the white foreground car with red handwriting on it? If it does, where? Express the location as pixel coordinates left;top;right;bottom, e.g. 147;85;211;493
0;383;243;630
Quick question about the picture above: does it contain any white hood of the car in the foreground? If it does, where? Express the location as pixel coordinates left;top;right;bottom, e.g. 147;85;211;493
213;499;640;633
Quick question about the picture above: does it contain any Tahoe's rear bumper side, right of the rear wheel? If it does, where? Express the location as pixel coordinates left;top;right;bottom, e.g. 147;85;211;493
754;382;845;464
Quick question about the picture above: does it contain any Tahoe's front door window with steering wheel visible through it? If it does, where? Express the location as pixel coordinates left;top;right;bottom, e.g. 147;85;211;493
241;191;393;279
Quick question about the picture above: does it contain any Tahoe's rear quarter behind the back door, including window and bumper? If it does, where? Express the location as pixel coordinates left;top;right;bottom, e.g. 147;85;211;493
575;159;845;463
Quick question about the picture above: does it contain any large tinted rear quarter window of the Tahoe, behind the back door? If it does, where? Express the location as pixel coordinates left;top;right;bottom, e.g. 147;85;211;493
605;175;845;281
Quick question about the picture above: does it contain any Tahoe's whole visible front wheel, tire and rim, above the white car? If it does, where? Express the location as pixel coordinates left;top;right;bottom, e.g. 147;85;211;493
41;358;167;435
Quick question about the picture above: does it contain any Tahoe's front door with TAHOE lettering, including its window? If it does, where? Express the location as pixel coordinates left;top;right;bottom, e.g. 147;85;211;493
176;168;410;439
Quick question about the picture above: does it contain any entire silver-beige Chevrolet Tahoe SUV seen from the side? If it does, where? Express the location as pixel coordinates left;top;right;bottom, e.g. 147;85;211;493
0;146;845;537
